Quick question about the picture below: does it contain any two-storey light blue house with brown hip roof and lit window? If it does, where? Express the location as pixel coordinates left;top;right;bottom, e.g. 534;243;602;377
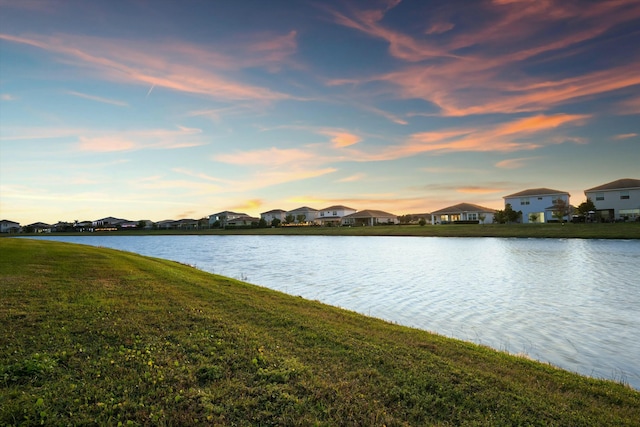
503;188;571;224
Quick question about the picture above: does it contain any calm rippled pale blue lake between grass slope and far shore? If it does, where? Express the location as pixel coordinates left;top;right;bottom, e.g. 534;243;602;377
25;235;640;389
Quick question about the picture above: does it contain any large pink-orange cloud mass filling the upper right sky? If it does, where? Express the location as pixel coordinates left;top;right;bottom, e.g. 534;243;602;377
329;1;640;116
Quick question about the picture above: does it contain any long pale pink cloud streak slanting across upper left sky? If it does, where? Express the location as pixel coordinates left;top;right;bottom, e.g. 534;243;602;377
0;34;291;101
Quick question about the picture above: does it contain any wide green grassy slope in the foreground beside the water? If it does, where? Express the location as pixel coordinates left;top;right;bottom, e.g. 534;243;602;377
0;239;640;426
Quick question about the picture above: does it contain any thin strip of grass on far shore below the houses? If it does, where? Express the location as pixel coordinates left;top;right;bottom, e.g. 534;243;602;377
16;222;640;239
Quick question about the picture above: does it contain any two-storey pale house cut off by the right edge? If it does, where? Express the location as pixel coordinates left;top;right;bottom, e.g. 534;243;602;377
584;178;640;221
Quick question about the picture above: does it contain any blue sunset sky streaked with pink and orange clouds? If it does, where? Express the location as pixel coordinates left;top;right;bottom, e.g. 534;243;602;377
0;0;640;225
